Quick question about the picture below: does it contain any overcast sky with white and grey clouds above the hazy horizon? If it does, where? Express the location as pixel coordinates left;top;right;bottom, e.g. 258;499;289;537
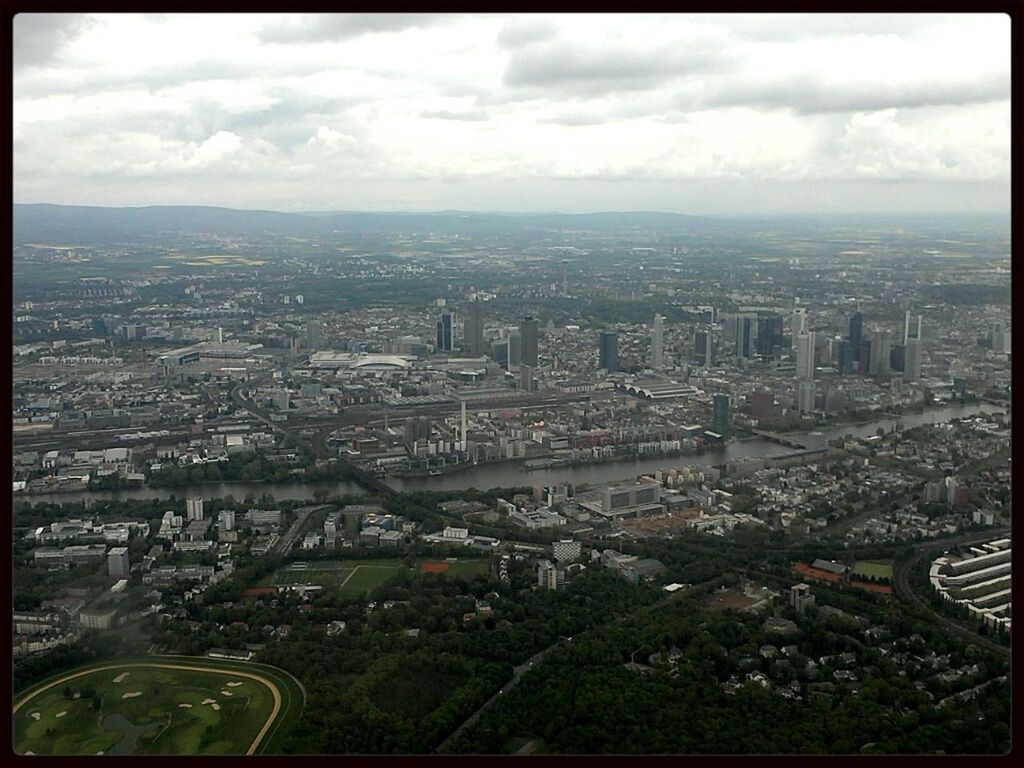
13;14;1010;214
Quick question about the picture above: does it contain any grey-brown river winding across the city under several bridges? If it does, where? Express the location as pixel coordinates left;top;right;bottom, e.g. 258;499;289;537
15;403;1004;503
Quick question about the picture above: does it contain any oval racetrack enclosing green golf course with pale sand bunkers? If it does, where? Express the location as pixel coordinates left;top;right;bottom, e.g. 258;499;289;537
13;658;294;755
